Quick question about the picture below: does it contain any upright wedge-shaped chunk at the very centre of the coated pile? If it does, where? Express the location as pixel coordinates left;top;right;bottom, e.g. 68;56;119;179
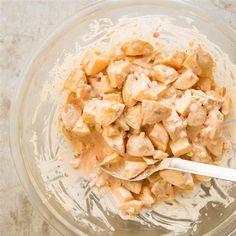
125;104;142;132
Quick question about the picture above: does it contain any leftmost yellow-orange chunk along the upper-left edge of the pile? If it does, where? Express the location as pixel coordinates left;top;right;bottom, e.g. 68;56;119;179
63;68;87;93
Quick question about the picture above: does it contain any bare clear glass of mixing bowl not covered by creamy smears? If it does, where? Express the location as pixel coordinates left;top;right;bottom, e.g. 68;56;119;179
10;0;236;236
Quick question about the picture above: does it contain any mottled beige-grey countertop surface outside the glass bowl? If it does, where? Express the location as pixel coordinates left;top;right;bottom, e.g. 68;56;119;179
0;0;236;236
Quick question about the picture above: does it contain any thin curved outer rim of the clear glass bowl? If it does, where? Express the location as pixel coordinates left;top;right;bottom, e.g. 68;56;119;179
9;0;236;235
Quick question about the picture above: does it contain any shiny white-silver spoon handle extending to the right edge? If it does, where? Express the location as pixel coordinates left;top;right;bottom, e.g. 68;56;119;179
167;158;236;182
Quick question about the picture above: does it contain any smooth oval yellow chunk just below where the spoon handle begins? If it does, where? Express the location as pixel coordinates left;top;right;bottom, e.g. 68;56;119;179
159;170;187;187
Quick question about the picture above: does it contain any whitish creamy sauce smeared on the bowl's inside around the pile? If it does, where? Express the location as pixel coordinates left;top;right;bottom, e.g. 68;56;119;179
32;16;235;232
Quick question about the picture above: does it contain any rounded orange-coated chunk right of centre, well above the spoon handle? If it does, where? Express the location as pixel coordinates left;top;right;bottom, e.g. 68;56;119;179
187;102;207;126
